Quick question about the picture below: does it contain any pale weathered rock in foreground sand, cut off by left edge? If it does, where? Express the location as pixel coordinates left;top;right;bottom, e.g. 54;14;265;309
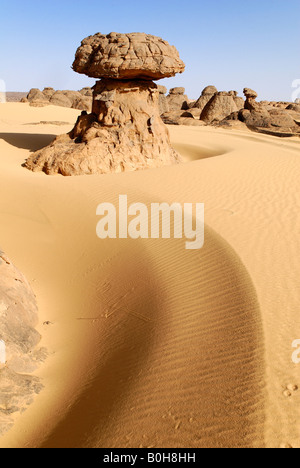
0;251;45;433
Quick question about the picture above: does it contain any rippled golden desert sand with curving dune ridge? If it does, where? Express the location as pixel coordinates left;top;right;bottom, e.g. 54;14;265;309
0;103;300;448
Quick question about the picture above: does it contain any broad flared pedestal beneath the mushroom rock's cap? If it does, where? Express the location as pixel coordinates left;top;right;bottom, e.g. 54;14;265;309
26;80;180;176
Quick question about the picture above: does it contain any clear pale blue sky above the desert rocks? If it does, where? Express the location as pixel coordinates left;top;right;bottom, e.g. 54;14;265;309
0;0;300;101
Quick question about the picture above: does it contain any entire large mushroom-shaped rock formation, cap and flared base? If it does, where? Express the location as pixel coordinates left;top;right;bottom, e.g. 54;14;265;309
25;33;185;176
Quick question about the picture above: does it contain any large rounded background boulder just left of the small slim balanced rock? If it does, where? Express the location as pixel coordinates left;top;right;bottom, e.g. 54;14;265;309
201;92;238;123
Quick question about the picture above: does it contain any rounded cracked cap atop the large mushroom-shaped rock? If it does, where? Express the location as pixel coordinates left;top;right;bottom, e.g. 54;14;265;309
73;33;185;81
